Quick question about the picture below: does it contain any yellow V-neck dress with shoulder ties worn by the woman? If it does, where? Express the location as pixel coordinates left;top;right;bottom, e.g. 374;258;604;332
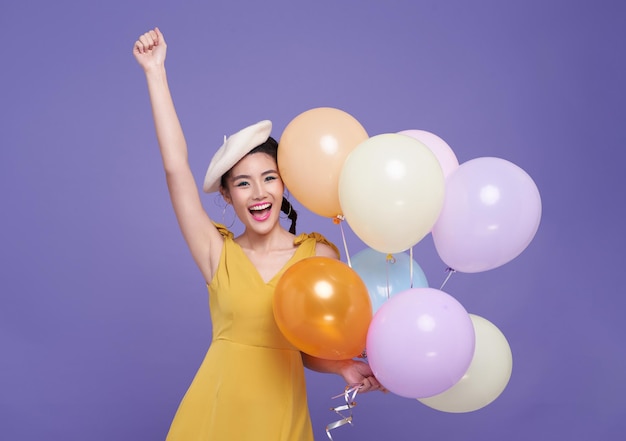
167;225;339;441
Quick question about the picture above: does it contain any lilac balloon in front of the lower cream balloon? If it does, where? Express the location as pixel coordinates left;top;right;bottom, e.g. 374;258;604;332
366;288;475;398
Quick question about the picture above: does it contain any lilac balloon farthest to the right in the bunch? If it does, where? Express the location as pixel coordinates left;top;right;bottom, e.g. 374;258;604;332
432;157;541;273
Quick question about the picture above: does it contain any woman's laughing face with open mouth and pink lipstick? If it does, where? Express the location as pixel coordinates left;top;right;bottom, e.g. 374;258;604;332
222;153;284;234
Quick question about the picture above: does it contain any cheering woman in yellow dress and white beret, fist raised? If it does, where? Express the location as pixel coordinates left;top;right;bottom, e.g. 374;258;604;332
133;28;381;441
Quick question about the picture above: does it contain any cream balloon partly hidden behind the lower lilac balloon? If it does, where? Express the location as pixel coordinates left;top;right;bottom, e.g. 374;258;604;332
419;314;513;413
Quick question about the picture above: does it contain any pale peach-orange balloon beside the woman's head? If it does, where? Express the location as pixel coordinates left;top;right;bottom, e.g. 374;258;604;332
278;107;368;218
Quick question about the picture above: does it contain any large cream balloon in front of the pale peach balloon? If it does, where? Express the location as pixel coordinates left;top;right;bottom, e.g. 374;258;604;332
339;133;445;253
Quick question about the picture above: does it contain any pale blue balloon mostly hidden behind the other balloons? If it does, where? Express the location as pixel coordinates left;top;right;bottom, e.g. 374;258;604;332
350;248;428;314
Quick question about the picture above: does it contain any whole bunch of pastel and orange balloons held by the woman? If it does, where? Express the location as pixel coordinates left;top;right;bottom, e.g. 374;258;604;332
274;107;541;412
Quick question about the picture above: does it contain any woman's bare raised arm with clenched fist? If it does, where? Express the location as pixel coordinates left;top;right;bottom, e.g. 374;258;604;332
133;28;223;283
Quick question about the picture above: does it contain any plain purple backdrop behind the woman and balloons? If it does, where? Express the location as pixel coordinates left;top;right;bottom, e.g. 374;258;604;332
0;0;626;441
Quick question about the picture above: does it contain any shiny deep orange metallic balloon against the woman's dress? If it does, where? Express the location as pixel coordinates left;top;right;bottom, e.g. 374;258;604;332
273;257;372;360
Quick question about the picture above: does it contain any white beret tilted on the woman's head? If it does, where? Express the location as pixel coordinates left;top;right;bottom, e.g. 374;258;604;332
202;120;272;193
